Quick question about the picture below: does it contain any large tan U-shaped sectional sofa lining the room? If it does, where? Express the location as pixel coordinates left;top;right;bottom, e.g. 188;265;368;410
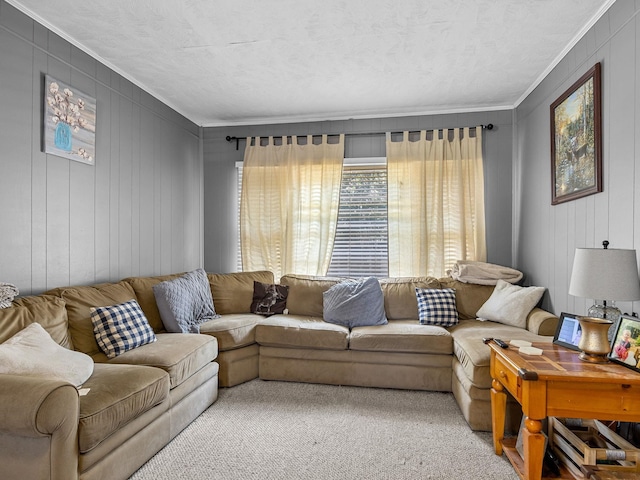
0;272;558;480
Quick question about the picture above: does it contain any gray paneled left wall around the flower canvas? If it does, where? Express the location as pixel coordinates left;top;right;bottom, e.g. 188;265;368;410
0;0;203;294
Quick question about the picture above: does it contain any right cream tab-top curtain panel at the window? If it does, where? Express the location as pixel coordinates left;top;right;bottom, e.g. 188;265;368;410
387;127;487;277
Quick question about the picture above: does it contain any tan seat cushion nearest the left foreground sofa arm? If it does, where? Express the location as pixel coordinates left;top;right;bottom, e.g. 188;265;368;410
78;364;169;453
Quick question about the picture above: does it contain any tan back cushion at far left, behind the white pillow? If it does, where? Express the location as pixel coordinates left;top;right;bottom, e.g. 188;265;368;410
0;295;73;350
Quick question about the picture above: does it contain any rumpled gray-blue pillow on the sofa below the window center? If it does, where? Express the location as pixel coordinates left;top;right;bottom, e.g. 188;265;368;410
322;277;387;328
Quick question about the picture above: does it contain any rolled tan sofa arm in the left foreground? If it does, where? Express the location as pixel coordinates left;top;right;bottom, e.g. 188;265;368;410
0;375;80;480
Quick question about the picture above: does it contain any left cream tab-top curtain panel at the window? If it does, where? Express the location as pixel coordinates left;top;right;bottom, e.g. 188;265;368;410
240;135;344;280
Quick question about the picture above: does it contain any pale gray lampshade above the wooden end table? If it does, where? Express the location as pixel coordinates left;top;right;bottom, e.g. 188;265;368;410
569;248;640;301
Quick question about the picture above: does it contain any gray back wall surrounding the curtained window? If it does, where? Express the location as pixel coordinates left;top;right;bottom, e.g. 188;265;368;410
203;110;512;272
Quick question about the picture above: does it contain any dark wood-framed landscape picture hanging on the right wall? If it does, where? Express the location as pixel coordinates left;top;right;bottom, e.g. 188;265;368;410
551;63;602;205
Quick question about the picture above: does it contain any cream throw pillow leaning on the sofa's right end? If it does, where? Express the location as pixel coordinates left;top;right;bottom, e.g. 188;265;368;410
477;280;545;328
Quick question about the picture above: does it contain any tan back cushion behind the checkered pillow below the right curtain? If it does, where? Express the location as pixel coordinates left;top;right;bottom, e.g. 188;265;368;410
380;277;441;321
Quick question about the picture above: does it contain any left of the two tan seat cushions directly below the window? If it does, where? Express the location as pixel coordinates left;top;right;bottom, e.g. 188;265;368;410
256;314;349;350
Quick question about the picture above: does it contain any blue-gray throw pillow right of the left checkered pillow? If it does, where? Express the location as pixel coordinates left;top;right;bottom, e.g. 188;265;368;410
153;268;220;333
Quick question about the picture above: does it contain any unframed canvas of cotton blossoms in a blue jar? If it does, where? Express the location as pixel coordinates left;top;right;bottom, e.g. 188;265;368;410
43;75;96;165
